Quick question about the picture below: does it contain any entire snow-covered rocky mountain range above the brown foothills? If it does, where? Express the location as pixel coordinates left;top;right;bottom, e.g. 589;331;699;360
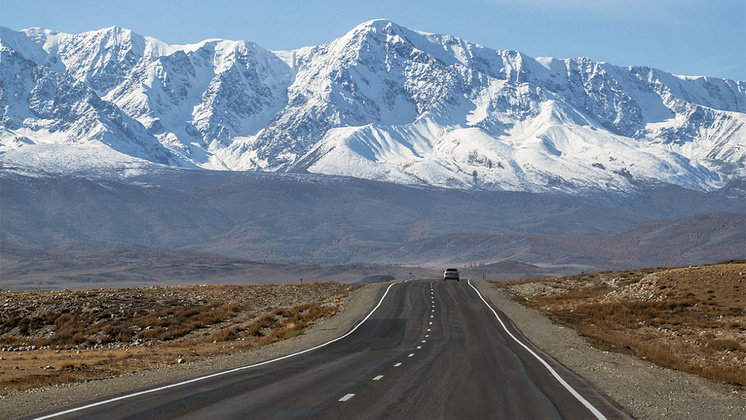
0;20;746;193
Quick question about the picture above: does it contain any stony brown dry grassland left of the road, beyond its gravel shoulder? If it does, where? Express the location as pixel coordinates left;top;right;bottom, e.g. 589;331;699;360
0;282;351;395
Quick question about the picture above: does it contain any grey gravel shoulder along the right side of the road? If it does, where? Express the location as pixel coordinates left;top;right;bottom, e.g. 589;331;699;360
473;281;746;419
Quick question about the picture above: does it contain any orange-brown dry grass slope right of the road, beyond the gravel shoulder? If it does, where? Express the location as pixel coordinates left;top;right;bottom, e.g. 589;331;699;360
499;261;746;387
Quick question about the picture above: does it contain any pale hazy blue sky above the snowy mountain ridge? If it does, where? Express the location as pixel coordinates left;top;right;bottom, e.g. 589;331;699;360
0;0;746;80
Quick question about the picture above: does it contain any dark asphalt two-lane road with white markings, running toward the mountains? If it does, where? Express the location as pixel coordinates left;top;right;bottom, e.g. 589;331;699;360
32;280;629;420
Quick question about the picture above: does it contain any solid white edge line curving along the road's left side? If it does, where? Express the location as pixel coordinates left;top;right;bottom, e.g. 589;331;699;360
35;281;400;420
